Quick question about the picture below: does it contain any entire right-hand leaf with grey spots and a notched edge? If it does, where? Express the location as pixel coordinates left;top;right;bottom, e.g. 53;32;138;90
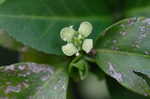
96;18;150;96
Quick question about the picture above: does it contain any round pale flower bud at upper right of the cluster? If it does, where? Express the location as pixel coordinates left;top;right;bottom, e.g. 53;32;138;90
78;22;93;37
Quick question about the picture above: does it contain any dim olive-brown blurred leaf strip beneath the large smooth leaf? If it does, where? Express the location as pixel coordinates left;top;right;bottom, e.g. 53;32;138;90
0;30;70;67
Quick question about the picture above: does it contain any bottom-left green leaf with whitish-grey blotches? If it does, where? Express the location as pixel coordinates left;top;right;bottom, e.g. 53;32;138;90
0;63;68;99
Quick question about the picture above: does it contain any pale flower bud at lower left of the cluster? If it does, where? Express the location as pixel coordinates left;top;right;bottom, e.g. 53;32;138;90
62;43;78;56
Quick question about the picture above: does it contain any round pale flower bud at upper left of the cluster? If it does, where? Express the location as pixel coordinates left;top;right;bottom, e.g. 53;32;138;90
60;27;75;41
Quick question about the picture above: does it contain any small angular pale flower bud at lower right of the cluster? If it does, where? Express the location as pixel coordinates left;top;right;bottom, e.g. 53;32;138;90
82;39;93;53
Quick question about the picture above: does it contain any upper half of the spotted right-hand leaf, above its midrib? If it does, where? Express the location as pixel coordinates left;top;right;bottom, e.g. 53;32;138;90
95;17;150;54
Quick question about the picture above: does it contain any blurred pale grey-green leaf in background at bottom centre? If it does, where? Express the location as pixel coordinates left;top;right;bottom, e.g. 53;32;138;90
79;73;110;99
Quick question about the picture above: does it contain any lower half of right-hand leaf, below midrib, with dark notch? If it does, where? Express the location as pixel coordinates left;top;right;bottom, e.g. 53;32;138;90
97;50;150;96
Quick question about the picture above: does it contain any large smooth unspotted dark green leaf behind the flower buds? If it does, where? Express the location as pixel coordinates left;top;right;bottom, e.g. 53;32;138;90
0;0;111;55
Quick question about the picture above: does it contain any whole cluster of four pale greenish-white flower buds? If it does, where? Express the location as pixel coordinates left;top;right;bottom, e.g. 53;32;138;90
60;22;93;56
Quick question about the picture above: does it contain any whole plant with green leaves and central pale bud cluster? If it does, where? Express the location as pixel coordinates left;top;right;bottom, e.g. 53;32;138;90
0;0;150;99
